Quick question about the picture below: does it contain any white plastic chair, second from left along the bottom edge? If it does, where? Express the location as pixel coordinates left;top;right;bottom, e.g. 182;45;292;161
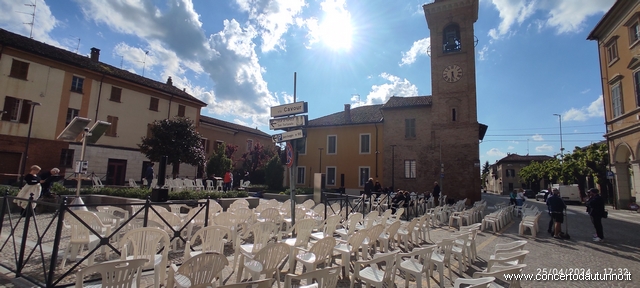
167;252;229;288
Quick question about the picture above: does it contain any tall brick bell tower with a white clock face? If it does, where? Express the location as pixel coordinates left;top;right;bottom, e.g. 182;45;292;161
423;0;481;204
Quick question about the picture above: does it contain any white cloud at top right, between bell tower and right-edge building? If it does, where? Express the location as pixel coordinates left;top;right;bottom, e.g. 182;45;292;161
489;0;615;39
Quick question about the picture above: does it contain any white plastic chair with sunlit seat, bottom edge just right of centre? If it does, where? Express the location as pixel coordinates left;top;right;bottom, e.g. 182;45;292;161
350;252;398;288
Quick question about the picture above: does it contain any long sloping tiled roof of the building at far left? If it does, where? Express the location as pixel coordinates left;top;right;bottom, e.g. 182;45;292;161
0;29;207;107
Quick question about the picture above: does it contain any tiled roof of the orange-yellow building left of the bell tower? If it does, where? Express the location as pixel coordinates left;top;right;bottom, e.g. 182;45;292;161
307;104;383;127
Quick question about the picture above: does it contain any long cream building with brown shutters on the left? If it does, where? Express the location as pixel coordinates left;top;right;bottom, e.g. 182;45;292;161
0;29;206;185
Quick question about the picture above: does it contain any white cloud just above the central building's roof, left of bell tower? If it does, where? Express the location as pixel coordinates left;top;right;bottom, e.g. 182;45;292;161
351;73;418;107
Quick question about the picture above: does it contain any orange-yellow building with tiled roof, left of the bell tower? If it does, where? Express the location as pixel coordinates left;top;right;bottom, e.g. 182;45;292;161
295;104;382;194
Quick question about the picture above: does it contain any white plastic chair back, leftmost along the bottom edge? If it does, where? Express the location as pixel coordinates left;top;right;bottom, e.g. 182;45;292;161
76;259;147;288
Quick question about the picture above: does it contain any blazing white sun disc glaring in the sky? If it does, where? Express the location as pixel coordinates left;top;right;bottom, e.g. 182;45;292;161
320;9;352;50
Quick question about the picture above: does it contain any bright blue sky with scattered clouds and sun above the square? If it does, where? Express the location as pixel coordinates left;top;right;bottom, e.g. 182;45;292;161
0;0;614;163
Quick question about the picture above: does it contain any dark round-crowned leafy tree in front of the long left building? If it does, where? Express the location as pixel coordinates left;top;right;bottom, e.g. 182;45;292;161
138;117;205;177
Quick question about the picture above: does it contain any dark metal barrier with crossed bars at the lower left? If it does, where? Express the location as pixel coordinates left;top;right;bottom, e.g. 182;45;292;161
0;194;211;287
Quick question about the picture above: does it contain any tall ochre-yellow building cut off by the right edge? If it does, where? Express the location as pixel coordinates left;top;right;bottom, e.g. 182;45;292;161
587;0;640;208
